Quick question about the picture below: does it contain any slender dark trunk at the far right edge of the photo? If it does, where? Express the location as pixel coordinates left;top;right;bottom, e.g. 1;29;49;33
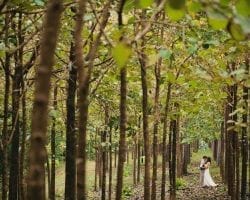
241;58;250;200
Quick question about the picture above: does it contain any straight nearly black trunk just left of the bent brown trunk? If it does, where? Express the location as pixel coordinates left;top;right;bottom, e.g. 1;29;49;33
65;43;77;200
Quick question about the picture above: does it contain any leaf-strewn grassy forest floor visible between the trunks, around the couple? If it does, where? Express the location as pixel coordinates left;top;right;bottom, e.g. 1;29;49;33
53;148;229;200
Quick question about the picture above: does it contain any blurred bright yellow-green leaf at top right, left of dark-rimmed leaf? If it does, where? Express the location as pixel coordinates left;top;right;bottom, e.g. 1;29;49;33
207;11;228;30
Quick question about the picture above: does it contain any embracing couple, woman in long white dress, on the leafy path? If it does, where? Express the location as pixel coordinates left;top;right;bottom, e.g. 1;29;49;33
200;156;218;187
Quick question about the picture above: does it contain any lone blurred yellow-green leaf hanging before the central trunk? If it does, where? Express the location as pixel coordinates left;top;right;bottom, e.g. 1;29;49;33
112;43;131;67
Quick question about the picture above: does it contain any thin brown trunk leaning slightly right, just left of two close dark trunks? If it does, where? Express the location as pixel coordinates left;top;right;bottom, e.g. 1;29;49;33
161;83;171;200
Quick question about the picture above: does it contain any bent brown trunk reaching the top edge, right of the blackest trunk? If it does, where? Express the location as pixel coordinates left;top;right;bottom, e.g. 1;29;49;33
74;0;89;200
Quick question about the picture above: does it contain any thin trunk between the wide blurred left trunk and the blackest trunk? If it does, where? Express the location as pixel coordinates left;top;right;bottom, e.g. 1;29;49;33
50;85;57;200
